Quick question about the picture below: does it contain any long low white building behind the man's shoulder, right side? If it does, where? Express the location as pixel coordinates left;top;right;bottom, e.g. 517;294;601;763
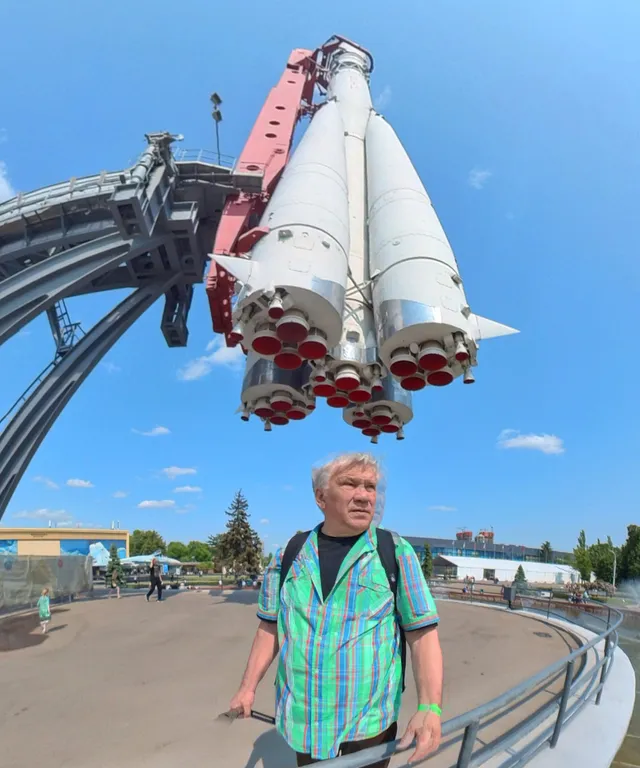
433;555;581;584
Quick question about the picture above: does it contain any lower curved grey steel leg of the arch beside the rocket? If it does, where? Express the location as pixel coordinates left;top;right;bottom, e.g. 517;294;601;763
0;275;180;518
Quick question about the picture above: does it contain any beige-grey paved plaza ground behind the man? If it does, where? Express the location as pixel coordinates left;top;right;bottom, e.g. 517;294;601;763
0;590;575;768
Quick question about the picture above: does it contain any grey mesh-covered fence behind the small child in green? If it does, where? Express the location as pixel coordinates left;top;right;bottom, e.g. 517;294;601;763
0;555;93;614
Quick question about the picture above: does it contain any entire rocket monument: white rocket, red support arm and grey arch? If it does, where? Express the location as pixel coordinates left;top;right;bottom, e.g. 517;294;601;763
0;36;515;518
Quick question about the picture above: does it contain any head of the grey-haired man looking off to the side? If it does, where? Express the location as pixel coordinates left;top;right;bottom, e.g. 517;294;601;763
316;464;378;535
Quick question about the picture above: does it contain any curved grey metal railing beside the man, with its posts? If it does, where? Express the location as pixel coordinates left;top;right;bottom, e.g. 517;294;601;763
324;596;624;768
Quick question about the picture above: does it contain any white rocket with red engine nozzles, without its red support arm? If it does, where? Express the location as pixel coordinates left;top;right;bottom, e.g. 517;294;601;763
212;39;517;442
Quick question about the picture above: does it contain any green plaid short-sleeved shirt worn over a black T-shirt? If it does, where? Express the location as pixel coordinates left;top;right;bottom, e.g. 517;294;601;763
258;526;438;760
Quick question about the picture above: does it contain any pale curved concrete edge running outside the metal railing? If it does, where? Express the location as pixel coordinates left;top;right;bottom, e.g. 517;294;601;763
436;601;636;768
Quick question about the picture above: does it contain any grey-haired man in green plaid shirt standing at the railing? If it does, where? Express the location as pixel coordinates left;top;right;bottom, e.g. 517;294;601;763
231;453;442;768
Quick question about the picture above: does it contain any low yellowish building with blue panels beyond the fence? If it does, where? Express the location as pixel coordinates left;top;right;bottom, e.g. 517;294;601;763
0;527;129;565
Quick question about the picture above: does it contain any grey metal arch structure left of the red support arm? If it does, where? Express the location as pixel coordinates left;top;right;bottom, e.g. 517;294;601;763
0;133;238;518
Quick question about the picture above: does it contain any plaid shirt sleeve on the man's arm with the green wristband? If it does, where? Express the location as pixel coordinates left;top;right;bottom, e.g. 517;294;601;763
396;537;440;632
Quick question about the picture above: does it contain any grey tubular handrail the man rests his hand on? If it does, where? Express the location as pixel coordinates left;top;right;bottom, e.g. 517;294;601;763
323;596;624;768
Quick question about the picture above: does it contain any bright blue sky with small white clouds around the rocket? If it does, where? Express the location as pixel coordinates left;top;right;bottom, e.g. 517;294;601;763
0;0;640;549
